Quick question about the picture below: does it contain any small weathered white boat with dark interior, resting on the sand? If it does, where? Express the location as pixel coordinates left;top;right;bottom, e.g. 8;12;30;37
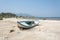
17;21;39;28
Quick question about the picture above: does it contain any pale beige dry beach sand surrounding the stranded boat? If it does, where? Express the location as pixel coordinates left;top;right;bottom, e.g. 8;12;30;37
0;20;60;40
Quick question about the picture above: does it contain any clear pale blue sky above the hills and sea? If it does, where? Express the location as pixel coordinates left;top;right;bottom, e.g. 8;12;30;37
0;0;60;17
